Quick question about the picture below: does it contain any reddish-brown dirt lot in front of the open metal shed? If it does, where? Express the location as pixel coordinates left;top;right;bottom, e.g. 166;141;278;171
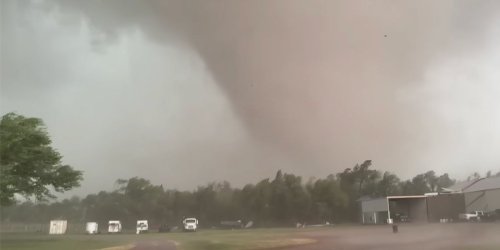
292;223;500;250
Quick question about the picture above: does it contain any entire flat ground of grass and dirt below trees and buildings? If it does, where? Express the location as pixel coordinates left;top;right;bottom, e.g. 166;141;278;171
0;223;500;250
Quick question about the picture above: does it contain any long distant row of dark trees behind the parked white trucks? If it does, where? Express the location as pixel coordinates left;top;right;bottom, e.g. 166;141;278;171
1;160;498;227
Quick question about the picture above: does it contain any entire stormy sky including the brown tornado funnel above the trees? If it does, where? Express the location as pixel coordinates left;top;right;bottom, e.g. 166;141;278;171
0;0;500;195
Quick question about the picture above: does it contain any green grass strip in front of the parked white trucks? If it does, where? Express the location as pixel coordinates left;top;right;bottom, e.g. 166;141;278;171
0;229;318;250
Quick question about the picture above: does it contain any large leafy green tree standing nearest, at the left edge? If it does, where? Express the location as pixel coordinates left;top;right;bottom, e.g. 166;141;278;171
0;113;82;205
